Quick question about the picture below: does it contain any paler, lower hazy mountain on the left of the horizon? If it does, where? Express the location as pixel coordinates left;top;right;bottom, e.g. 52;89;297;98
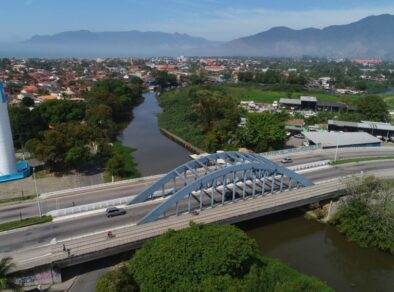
22;30;217;56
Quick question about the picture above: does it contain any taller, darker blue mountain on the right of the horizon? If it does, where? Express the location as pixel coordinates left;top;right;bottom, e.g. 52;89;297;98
217;14;394;58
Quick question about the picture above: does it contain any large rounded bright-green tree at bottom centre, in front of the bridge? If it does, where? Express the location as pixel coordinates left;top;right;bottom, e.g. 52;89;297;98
129;224;257;291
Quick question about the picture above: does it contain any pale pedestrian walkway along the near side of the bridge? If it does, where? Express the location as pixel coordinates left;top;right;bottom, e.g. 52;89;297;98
14;179;344;270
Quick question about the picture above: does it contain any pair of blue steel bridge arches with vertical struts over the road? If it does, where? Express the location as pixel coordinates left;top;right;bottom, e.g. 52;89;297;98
129;152;312;224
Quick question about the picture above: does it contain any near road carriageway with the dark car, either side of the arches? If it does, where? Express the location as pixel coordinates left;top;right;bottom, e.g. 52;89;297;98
0;160;394;253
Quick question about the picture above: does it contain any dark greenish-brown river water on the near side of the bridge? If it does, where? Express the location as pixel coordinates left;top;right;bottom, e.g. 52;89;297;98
239;211;394;291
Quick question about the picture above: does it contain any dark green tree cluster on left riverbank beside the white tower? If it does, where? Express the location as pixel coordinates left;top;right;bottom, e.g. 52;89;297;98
10;79;142;177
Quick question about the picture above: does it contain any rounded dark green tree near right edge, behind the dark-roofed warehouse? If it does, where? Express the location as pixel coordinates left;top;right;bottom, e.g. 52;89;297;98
357;96;390;122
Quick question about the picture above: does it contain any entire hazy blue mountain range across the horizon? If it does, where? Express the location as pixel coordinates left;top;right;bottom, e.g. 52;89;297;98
0;14;394;59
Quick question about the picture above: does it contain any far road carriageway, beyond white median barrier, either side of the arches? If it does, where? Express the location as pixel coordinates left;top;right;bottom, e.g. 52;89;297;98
0;147;394;223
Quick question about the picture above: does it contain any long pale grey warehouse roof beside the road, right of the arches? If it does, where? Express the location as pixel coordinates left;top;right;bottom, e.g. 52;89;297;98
303;132;381;148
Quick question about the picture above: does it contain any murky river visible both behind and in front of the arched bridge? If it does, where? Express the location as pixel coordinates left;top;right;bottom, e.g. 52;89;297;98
121;93;394;292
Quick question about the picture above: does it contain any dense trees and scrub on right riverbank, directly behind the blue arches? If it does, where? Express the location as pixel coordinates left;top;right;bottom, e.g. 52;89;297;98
159;85;286;152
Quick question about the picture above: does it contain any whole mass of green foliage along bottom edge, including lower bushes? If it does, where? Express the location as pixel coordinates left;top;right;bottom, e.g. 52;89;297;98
96;223;332;292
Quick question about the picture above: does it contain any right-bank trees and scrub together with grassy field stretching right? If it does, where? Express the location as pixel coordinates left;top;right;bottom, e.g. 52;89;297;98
158;83;389;152
